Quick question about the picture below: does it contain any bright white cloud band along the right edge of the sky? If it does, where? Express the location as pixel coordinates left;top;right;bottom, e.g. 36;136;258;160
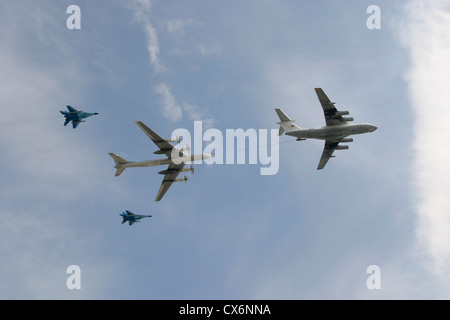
401;0;450;280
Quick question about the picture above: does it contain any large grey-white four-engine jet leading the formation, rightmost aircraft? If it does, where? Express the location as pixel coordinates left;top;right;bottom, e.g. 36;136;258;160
275;88;377;170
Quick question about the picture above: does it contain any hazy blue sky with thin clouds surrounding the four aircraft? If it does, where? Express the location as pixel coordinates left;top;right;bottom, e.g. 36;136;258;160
0;0;450;300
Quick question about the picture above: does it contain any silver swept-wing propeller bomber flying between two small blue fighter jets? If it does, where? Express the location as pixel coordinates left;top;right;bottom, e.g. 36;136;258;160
109;121;211;201
